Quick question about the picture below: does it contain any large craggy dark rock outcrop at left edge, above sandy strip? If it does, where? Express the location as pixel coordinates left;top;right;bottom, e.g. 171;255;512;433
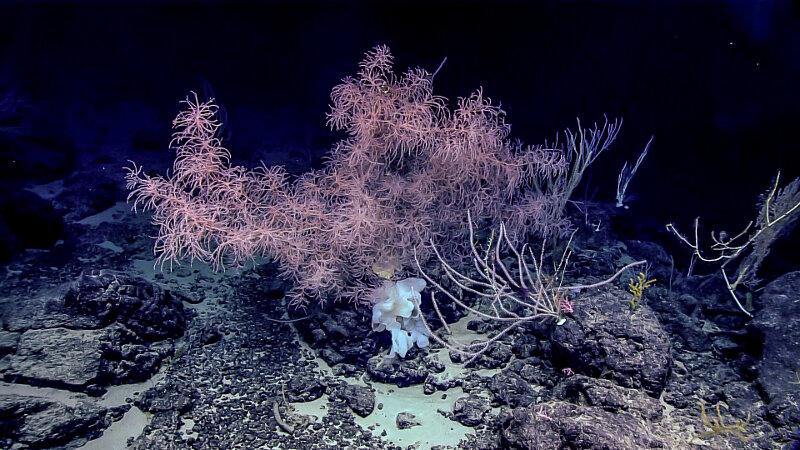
1;270;188;395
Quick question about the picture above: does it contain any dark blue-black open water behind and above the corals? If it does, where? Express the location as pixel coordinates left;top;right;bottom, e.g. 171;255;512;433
0;1;800;268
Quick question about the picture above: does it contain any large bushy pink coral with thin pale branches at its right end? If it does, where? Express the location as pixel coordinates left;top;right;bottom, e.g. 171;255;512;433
127;46;618;306
